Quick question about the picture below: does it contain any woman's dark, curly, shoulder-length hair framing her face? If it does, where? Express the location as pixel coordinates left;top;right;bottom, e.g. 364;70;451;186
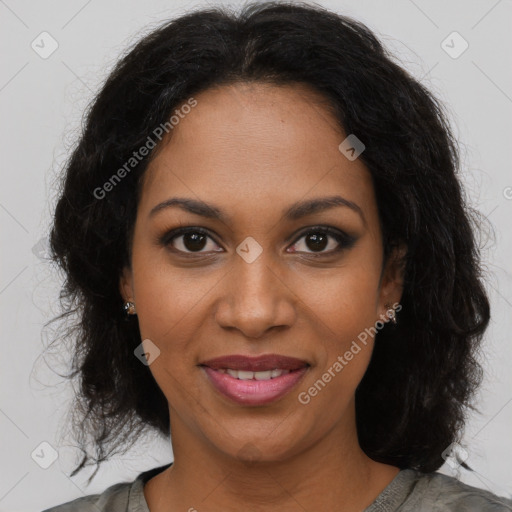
50;2;490;478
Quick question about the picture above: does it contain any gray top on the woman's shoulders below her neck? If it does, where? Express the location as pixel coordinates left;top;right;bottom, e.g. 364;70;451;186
43;464;512;512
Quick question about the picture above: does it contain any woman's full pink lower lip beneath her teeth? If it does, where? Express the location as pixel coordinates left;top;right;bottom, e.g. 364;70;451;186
202;366;308;405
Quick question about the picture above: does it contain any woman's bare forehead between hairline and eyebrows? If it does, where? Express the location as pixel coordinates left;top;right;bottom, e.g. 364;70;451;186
140;83;376;228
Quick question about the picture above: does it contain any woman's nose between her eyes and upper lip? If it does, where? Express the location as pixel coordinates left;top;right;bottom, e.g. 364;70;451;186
215;251;297;338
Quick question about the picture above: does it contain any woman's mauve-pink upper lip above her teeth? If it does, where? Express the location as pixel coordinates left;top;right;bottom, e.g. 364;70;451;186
200;354;309;372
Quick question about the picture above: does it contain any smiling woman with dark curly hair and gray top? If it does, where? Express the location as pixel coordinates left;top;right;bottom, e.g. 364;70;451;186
43;3;512;512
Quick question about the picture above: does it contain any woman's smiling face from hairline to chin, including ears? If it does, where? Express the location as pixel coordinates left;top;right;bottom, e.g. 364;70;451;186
121;83;401;460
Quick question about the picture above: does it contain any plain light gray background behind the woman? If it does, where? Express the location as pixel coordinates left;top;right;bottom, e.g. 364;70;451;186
0;0;512;512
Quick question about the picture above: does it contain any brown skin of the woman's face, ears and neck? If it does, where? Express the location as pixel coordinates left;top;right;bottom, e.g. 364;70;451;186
120;83;402;512
